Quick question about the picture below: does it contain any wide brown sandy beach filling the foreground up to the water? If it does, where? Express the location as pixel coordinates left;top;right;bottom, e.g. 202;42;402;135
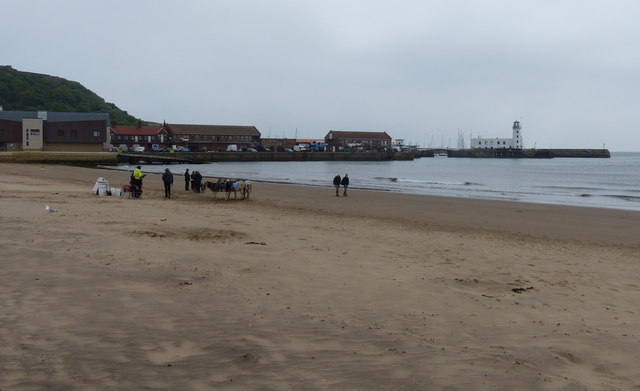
0;164;640;391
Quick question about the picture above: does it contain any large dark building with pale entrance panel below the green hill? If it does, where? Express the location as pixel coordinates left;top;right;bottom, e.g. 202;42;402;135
0;111;111;152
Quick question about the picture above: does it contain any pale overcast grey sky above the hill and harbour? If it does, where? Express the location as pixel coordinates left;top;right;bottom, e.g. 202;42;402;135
5;0;640;151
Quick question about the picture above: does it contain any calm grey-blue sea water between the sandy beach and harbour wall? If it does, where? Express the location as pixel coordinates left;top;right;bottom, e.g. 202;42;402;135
112;152;640;210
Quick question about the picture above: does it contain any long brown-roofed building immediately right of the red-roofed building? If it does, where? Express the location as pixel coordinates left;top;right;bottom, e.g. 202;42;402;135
164;124;260;152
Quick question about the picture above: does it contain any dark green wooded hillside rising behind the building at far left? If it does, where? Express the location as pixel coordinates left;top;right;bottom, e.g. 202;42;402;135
0;65;138;125
